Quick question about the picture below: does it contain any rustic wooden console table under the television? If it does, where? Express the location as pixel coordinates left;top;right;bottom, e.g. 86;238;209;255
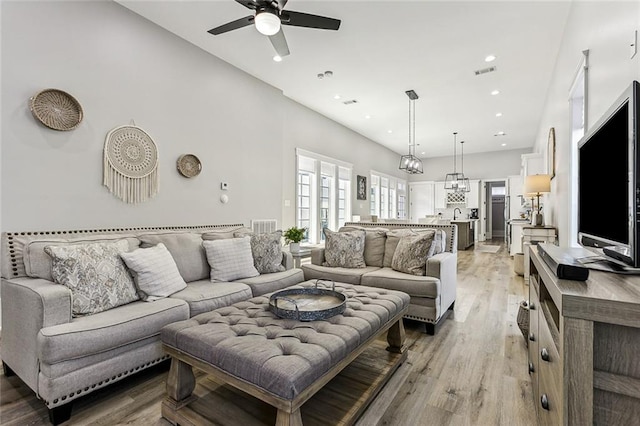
529;246;640;425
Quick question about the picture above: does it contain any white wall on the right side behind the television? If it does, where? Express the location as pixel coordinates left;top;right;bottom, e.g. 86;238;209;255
535;1;640;245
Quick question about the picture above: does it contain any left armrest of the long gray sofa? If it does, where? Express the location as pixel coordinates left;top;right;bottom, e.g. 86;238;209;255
0;278;71;393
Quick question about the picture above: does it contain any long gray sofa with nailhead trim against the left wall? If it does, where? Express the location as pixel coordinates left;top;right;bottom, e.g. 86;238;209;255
0;224;304;424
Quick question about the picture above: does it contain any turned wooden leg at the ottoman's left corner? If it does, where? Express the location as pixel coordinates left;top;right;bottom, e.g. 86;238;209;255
162;358;196;424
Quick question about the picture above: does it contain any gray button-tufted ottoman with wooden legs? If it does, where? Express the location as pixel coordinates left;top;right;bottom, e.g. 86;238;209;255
162;280;409;425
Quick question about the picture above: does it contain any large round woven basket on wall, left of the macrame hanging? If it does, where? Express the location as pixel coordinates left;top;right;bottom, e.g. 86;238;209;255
29;89;83;131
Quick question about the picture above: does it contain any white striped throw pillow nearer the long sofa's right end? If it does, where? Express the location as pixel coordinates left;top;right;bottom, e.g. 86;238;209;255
202;237;260;282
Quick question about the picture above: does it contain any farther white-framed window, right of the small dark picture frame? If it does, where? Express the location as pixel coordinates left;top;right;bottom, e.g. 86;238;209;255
370;172;407;219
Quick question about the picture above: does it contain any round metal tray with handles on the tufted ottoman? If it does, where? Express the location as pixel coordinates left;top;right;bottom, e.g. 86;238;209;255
269;280;347;321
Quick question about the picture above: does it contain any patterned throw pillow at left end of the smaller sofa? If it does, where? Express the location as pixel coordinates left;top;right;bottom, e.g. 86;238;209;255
323;228;367;268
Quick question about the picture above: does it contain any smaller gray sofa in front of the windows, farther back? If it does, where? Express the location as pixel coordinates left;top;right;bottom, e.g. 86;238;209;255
301;222;458;335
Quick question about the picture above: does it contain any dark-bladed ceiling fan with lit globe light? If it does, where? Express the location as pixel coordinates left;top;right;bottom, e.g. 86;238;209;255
207;0;340;57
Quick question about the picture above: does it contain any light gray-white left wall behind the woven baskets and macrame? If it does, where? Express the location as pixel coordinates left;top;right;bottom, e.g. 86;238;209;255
0;1;404;231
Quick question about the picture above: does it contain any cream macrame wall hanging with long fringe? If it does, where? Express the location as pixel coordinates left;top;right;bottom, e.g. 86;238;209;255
103;122;158;204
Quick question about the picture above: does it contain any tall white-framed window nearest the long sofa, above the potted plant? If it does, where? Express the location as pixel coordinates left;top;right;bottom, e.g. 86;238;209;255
296;149;352;243
